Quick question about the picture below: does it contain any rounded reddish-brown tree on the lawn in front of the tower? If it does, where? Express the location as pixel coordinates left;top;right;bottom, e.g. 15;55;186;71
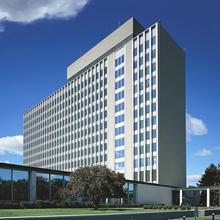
66;166;125;208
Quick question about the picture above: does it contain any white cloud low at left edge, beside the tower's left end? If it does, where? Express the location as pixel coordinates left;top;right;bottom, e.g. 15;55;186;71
0;135;23;155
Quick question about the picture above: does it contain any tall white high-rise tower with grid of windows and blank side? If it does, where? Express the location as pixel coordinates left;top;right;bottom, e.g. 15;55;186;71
24;18;186;186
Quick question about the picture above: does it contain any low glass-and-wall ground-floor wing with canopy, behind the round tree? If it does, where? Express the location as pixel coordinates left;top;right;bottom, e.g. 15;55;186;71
0;163;220;207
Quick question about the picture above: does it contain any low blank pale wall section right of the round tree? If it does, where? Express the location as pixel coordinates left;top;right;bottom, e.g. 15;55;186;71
135;184;174;205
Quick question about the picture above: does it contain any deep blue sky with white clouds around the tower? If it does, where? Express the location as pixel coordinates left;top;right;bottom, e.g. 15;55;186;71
0;0;220;184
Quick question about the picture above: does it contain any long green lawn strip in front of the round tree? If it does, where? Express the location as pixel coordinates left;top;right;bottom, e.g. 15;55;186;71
0;208;165;217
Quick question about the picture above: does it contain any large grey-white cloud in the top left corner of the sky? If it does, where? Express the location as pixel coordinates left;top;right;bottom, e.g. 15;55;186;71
0;0;90;31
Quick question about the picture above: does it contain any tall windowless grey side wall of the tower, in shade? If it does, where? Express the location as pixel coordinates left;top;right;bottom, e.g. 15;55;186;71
158;23;186;186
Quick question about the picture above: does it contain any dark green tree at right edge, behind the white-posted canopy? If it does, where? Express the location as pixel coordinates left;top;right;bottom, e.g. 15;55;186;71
197;164;220;206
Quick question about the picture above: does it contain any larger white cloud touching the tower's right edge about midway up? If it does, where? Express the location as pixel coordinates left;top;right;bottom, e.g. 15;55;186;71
186;113;208;141
